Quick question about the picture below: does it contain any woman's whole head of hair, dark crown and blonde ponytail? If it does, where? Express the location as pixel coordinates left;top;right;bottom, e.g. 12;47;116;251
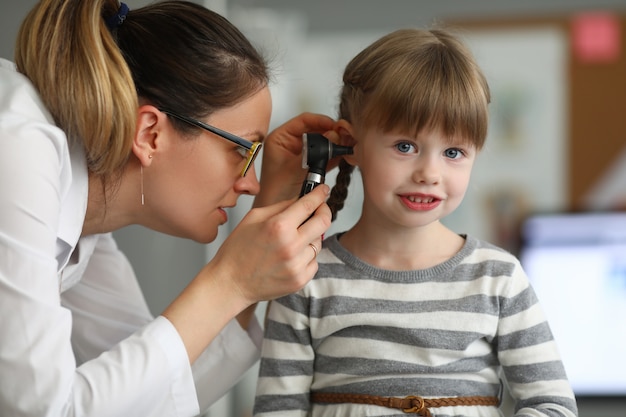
15;0;269;179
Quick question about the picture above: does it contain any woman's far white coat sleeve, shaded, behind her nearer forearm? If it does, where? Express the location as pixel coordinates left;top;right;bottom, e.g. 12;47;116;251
62;234;262;410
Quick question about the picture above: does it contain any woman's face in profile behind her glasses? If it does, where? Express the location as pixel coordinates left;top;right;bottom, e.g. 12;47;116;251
144;87;272;243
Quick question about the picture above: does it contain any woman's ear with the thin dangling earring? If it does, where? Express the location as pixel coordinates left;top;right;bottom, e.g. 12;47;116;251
133;105;161;166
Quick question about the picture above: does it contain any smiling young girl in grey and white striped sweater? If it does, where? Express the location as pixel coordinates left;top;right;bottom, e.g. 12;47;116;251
254;30;577;417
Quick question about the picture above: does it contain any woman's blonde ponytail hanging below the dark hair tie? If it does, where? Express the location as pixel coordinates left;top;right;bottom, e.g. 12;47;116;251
15;0;138;177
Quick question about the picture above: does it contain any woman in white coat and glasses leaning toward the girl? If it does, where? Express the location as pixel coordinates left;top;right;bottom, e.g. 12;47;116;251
0;0;333;417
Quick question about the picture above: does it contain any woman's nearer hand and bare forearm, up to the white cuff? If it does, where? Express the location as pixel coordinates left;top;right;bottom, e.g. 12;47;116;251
163;185;331;362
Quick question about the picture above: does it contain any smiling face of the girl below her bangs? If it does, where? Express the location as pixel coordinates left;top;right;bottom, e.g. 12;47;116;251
354;129;476;228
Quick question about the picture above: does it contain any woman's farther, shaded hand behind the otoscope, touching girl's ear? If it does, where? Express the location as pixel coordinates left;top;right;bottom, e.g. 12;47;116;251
254;113;336;207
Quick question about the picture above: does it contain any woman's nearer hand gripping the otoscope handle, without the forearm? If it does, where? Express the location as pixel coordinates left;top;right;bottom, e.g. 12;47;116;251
209;185;330;304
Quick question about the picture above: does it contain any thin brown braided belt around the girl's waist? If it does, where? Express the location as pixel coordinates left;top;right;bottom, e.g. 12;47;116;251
311;392;500;417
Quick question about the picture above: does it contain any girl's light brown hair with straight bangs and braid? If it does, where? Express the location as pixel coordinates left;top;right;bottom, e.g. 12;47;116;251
328;29;490;219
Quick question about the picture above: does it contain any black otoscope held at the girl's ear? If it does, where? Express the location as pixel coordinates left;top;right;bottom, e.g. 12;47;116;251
300;133;352;197
